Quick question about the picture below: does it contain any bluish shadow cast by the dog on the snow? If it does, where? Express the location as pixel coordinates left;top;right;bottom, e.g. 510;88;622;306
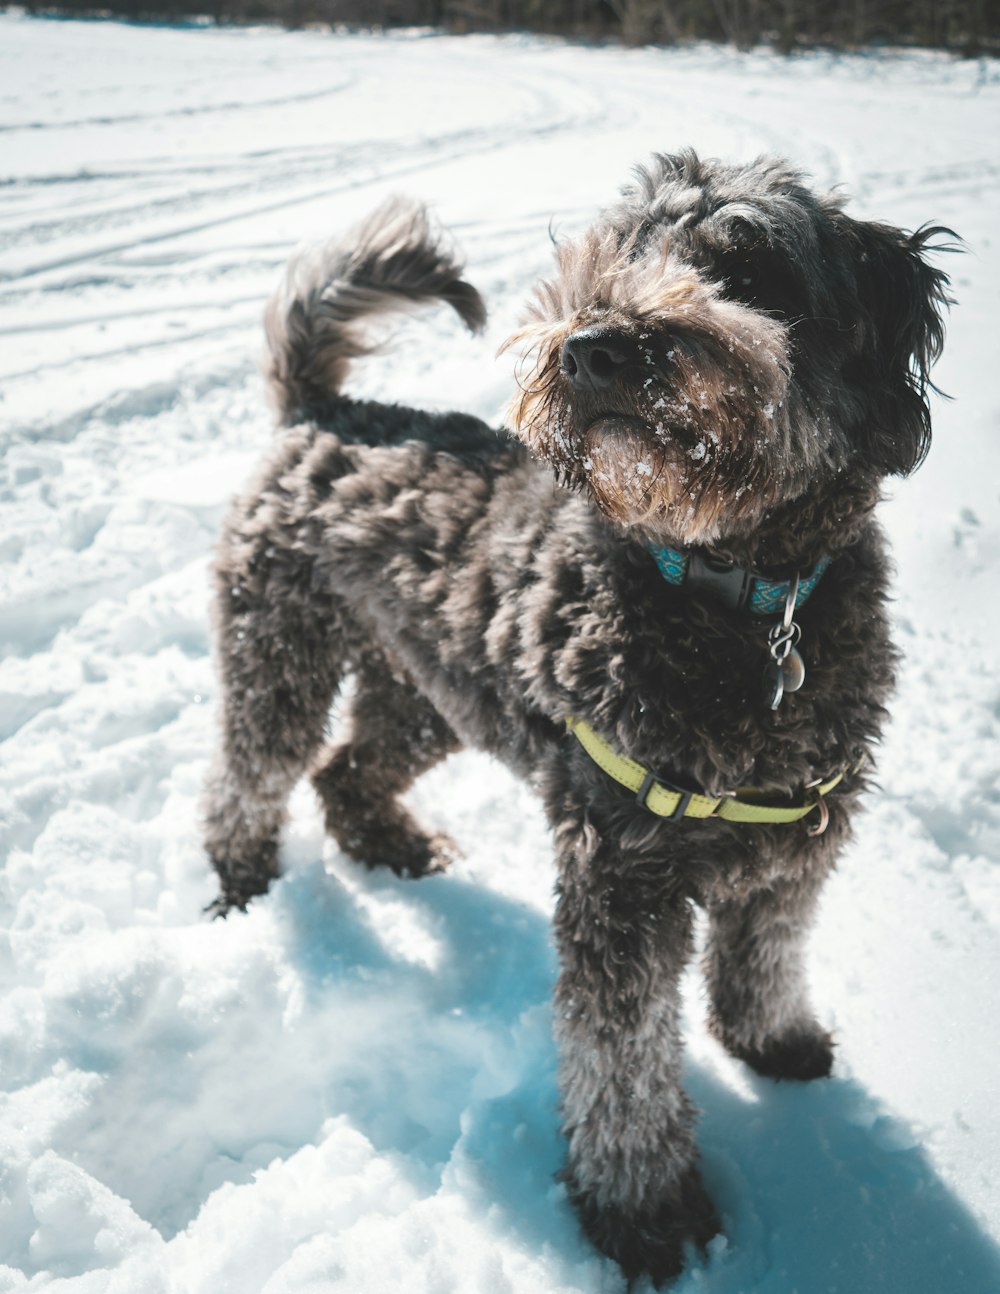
272;864;1000;1294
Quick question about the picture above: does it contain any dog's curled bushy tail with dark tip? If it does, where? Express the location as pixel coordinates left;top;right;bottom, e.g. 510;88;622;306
265;198;486;426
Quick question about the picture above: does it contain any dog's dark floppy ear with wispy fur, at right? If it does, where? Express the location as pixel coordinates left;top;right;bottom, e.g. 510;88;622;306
841;216;960;476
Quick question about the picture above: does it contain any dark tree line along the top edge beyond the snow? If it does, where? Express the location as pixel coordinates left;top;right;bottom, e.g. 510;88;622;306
9;0;1000;54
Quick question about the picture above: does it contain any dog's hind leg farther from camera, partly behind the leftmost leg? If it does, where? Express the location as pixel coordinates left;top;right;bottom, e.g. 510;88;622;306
313;652;461;876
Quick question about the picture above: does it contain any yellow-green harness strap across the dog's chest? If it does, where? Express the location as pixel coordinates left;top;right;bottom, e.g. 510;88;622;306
565;718;865;835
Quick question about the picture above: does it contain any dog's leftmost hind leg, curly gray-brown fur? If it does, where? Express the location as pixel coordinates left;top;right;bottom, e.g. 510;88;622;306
204;533;345;915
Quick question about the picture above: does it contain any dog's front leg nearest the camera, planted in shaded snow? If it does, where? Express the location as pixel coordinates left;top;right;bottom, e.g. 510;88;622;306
555;828;718;1284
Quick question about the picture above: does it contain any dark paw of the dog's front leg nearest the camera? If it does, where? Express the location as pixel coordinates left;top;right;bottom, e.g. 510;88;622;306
567;1167;722;1289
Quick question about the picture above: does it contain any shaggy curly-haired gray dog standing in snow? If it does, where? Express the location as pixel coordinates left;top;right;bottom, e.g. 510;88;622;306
200;153;950;1282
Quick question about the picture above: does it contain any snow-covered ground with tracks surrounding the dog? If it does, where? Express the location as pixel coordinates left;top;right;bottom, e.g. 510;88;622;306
0;14;1000;1294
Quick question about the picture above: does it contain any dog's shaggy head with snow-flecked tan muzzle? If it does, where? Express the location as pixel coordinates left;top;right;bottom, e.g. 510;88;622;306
508;153;950;543
